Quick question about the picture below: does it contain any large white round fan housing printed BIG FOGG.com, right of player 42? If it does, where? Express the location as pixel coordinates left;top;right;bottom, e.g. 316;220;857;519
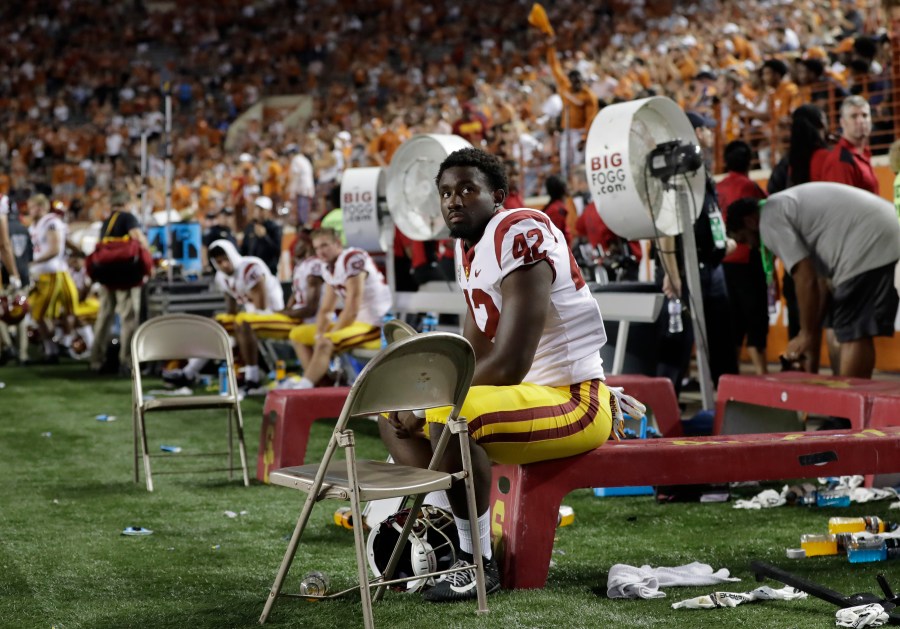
584;96;705;240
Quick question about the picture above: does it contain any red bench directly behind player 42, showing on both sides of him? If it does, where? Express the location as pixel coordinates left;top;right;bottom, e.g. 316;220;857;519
256;375;684;483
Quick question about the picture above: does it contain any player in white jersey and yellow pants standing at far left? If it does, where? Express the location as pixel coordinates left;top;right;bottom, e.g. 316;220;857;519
28;195;78;363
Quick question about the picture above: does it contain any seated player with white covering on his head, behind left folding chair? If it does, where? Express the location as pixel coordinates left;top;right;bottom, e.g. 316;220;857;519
163;240;284;392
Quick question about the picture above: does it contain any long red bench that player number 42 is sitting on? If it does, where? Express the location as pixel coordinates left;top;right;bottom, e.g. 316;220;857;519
491;427;900;589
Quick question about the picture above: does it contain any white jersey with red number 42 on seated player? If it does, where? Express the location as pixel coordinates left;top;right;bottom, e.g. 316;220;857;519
456;208;606;386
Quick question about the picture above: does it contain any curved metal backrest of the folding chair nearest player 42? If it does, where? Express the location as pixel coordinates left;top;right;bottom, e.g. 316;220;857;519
335;332;475;431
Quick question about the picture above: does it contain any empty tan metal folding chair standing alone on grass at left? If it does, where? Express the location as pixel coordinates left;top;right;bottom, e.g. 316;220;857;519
131;314;250;491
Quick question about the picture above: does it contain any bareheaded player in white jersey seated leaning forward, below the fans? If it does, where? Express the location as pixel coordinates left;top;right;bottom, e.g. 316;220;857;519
290;228;392;389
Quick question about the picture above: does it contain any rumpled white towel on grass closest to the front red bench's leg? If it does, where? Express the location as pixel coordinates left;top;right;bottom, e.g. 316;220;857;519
606;561;740;598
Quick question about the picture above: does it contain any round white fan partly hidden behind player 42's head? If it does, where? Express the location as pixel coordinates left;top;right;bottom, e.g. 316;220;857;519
387;134;472;241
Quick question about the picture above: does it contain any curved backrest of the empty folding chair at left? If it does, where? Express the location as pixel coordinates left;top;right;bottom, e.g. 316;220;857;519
131;314;231;363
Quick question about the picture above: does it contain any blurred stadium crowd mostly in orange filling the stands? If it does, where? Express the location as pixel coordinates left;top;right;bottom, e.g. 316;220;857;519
0;0;893;392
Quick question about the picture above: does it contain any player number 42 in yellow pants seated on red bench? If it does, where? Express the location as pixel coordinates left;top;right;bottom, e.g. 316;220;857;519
380;148;644;601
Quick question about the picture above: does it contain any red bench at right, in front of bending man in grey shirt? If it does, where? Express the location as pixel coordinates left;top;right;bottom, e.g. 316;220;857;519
713;371;900;435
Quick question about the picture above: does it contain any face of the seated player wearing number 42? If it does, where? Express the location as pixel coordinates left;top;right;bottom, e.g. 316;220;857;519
438;166;503;245
